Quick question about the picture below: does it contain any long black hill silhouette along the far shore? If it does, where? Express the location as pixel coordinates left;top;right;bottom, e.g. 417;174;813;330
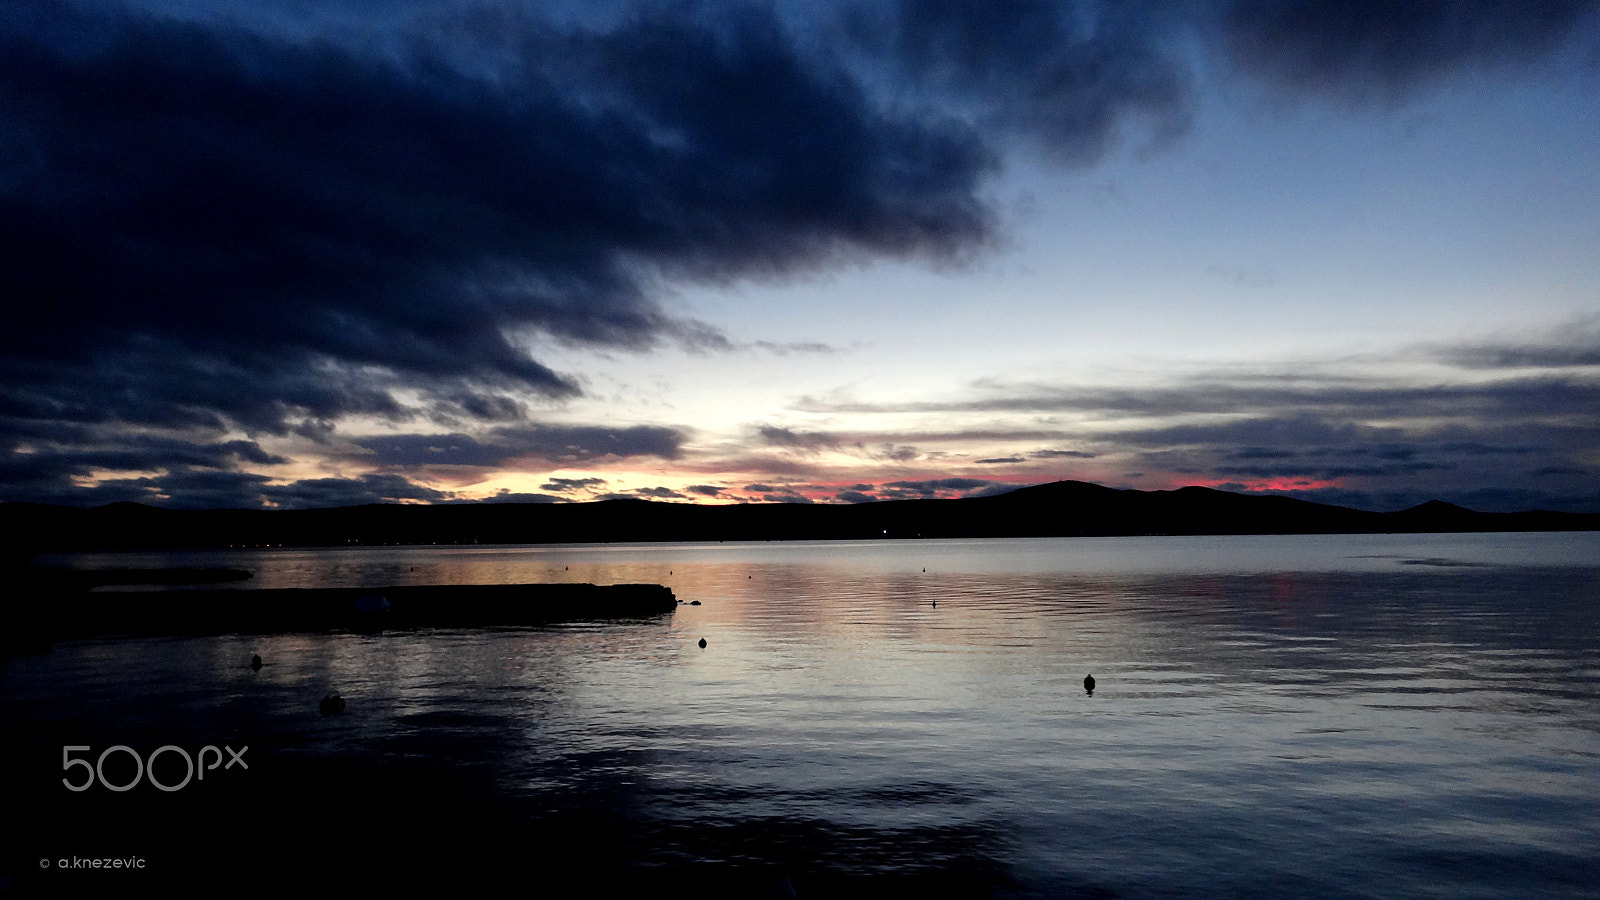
0;480;1600;552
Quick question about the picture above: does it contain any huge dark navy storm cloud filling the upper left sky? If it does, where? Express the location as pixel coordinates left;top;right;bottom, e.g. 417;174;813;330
0;0;992;441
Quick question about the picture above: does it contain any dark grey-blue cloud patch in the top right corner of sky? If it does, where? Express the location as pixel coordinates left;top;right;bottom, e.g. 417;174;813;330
1222;0;1600;102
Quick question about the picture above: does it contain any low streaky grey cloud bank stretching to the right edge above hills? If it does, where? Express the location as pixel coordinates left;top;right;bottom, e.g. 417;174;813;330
810;348;1600;509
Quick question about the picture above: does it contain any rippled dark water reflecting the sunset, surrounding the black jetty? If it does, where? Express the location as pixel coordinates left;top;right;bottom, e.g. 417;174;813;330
0;535;1600;898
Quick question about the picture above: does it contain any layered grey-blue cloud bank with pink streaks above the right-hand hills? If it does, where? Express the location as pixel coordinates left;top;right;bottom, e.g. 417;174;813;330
798;323;1600;509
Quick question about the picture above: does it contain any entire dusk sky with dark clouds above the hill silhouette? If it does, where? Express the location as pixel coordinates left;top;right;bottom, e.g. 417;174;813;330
0;0;1600;511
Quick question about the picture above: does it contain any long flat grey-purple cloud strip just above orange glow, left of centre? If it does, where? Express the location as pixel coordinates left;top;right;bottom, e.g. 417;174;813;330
354;424;685;470
